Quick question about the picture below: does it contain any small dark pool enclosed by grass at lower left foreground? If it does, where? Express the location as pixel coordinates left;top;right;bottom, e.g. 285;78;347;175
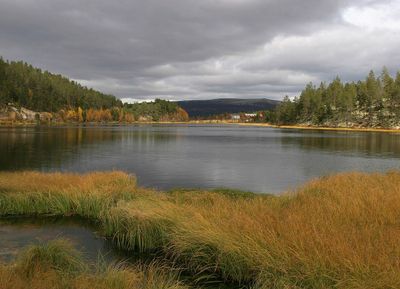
0;217;234;289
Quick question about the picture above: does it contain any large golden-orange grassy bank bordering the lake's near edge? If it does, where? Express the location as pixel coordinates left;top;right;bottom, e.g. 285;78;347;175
0;172;400;289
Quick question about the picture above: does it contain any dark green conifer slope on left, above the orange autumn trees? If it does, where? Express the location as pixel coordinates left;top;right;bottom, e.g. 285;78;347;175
0;58;122;112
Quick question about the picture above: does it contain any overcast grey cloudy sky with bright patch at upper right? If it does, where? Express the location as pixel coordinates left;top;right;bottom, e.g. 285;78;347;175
0;0;400;102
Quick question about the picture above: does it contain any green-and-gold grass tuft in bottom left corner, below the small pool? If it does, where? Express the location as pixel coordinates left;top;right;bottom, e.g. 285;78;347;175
0;240;188;289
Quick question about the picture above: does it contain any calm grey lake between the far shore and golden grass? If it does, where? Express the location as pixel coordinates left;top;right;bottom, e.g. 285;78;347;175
0;125;400;192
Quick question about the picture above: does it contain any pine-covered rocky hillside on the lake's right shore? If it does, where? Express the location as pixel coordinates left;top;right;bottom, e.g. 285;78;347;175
268;68;400;127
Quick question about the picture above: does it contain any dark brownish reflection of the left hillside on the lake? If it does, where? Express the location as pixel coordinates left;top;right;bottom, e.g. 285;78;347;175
0;126;178;170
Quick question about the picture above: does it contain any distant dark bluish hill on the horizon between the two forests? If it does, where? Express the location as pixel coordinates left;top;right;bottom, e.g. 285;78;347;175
178;98;280;117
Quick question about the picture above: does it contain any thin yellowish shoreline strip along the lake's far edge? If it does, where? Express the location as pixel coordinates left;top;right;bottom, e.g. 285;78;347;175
0;120;400;133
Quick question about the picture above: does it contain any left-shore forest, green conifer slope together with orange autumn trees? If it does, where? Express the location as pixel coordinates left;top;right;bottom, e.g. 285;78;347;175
0;57;188;122
